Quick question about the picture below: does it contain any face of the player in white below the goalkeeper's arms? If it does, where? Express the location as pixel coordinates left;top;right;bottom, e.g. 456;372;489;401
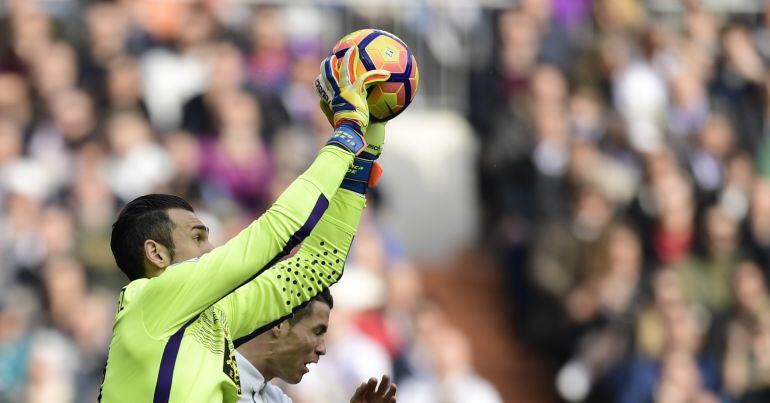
275;301;330;384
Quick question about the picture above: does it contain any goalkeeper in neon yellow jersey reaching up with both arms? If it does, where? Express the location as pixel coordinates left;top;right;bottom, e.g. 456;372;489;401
99;47;390;403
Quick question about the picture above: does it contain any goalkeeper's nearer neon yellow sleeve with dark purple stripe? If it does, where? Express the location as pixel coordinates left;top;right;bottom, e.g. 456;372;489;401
142;146;353;337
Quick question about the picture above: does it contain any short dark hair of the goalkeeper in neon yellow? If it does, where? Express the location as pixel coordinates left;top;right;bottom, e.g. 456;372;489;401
110;194;193;280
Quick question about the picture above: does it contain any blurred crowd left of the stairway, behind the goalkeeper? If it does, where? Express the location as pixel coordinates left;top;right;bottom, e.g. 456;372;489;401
0;0;501;403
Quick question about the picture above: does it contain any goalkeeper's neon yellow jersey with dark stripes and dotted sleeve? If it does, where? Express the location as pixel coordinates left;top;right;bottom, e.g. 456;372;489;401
100;146;365;403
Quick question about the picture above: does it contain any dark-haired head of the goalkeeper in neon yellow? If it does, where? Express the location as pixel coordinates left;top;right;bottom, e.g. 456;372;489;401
110;194;212;281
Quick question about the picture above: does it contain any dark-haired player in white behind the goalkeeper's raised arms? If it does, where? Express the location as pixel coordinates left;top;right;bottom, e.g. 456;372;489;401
235;290;396;403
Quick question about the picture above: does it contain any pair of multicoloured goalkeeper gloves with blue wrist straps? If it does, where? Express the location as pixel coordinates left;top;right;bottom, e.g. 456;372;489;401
315;46;390;194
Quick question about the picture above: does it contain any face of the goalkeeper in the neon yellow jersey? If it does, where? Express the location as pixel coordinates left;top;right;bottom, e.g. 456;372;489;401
168;209;213;263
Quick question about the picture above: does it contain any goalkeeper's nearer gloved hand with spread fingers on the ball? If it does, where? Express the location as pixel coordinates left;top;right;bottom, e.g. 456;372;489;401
315;46;390;159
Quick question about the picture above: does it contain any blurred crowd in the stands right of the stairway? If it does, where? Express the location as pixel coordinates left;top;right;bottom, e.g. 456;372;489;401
469;0;770;403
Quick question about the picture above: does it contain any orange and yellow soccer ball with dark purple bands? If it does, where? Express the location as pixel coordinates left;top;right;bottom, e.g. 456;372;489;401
332;29;420;122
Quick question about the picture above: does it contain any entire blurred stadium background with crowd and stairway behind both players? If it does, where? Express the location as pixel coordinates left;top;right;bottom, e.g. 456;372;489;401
0;0;770;403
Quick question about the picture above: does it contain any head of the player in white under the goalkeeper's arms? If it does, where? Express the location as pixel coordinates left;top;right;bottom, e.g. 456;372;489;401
238;289;334;384
